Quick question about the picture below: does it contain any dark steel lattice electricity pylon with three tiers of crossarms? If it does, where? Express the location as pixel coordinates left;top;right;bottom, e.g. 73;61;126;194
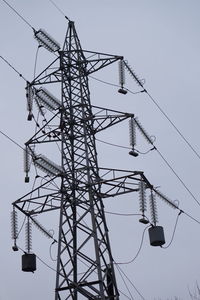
13;21;164;300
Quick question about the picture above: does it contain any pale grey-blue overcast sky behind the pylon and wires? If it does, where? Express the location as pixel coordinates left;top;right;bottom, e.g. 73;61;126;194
0;0;200;300
